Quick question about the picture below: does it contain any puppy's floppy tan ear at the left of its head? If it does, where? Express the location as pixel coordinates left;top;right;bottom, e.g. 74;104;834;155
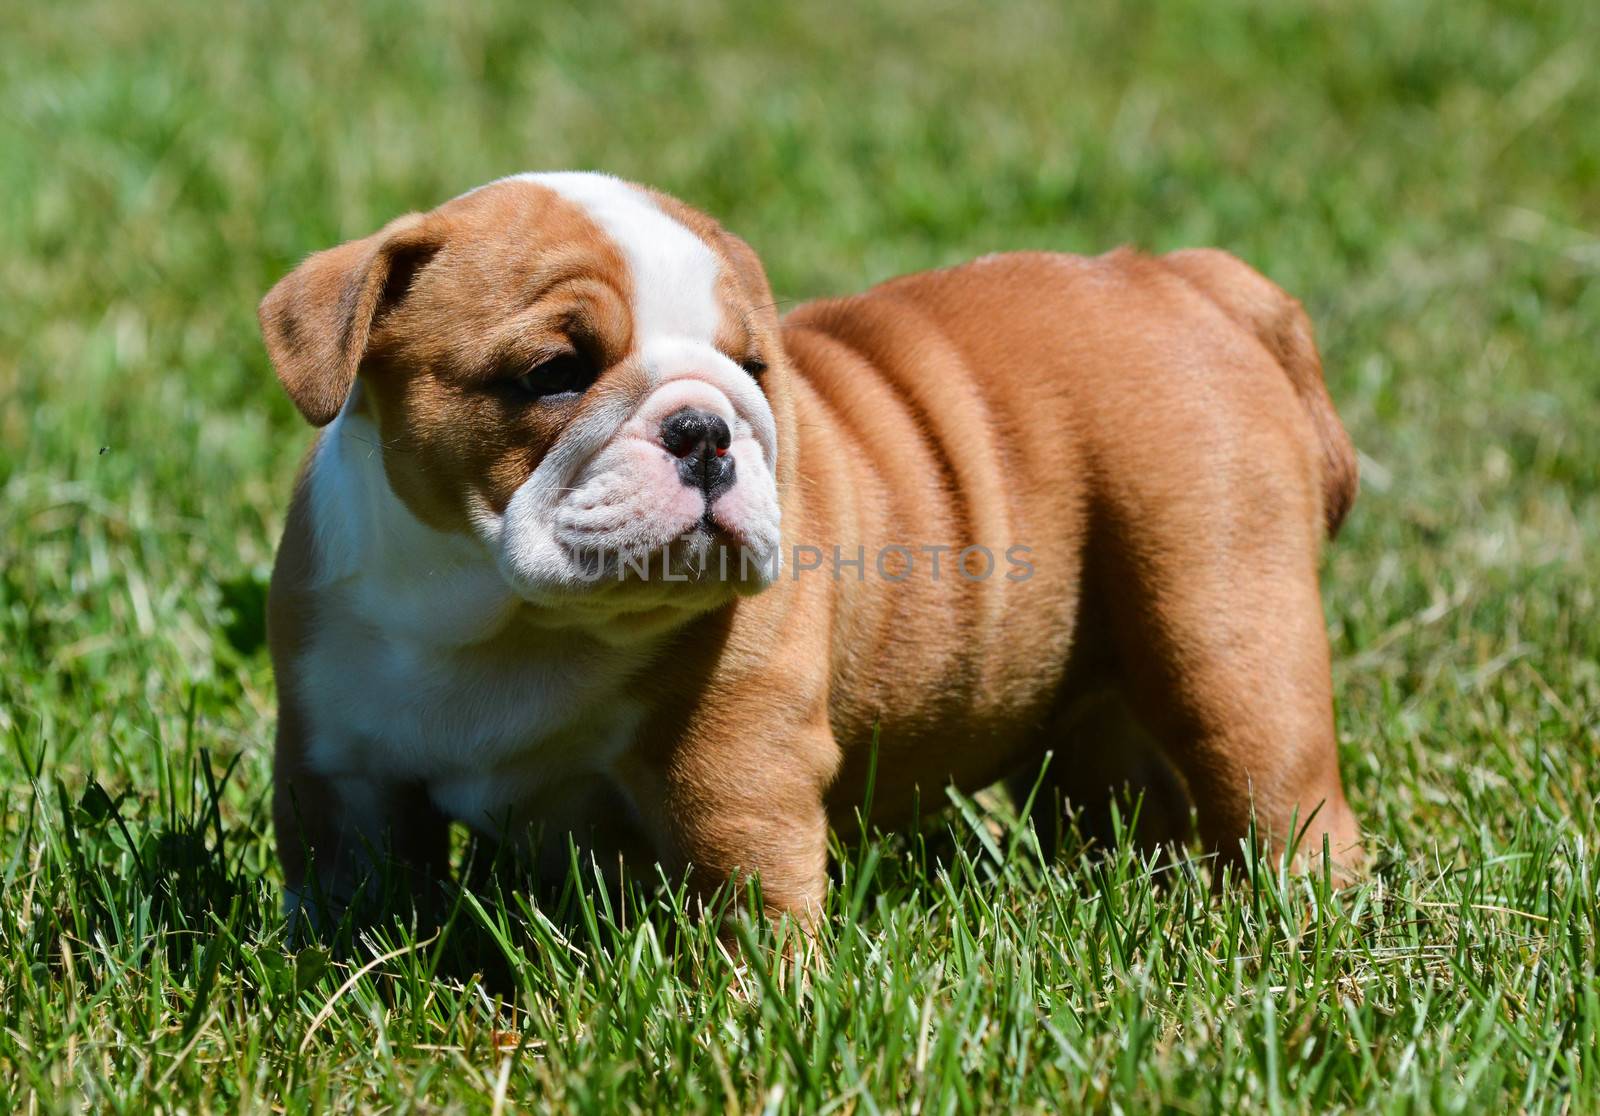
256;213;442;427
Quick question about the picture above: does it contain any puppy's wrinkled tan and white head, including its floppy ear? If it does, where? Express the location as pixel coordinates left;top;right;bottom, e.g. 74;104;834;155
261;174;787;611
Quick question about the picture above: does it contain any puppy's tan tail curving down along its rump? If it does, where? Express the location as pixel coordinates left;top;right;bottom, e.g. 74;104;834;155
1162;248;1358;539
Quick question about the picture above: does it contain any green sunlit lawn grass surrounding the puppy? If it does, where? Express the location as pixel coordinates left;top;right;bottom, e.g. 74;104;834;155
0;0;1600;1113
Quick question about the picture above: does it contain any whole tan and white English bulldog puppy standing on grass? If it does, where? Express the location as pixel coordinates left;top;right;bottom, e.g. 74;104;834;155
261;173;1362;923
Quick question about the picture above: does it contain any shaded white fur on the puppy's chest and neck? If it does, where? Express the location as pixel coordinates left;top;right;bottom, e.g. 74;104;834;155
296;394;646;831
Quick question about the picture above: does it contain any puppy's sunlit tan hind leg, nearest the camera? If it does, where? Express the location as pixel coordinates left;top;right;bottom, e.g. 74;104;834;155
1096;470;1362;878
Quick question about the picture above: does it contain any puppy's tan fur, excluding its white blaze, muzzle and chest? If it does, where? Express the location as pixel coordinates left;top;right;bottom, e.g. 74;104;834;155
262;175;1360;915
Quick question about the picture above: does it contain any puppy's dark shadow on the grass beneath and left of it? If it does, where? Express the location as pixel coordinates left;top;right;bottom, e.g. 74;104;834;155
53;751;1177;998
